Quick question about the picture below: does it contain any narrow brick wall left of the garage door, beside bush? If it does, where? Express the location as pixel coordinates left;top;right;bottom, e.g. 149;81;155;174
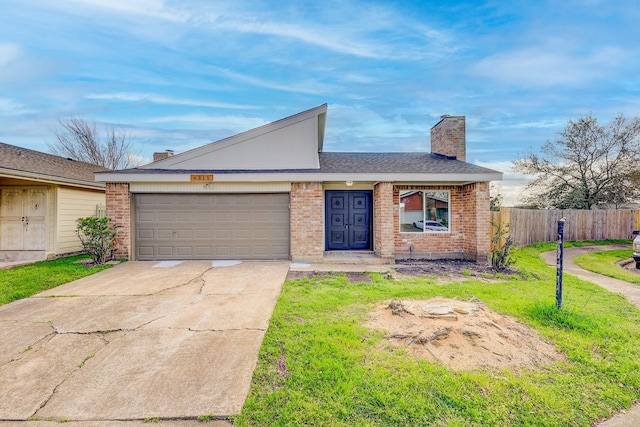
105;182;131;259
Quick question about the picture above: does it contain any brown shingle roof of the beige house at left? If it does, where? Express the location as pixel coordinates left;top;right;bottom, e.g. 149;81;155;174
0;142;109;186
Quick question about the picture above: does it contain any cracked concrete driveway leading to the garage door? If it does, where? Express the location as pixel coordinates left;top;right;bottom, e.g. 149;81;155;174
0;261;289;425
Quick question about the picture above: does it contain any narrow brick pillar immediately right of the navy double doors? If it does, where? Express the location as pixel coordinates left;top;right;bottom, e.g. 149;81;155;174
373;182;396;258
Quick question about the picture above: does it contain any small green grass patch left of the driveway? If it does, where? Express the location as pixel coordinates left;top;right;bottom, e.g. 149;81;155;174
0;255;111;305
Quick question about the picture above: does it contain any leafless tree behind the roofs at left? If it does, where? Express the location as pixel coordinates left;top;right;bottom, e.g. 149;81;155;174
49;117;139;170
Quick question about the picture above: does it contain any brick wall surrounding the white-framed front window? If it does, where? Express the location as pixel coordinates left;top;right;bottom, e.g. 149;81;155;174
392;183;490;262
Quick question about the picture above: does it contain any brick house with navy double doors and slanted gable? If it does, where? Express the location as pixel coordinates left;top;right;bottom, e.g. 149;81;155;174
96;104;502;262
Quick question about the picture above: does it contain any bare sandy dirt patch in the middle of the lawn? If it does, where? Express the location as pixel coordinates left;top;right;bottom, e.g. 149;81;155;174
368;297;564;371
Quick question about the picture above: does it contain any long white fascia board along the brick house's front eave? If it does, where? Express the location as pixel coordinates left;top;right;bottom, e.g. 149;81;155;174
96;172;502;183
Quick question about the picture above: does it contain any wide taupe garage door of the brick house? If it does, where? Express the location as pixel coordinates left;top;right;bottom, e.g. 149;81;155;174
134;194;289;260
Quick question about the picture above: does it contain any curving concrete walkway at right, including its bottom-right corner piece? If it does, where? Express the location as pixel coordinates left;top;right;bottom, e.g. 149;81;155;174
542;245;640;427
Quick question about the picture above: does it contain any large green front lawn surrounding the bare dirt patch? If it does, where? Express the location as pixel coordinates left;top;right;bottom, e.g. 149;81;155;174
235;244;640;426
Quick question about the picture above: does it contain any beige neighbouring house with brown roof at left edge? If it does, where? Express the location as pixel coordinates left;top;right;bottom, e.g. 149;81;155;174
0;142;106;261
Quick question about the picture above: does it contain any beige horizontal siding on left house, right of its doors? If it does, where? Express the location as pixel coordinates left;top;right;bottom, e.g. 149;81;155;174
55;187;105;254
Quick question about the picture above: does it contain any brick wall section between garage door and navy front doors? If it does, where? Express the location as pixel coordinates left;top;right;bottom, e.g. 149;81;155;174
291;182;324;261
